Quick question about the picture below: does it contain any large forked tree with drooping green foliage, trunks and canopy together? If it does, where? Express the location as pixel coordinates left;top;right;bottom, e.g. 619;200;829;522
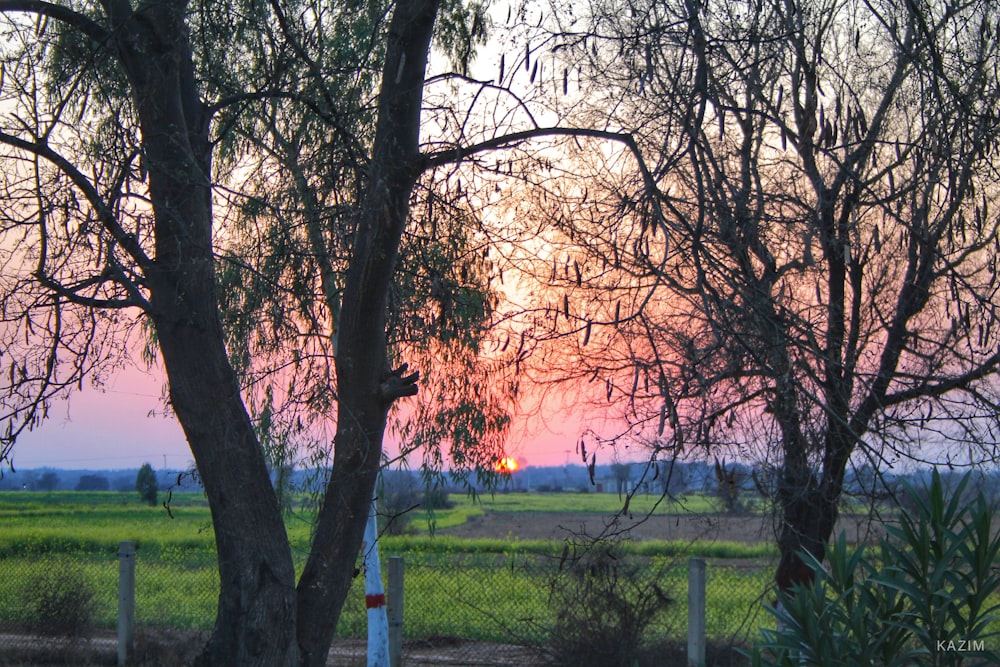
0;0;648;665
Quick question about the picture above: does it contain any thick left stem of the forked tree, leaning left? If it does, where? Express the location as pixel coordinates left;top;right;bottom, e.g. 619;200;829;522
106;1;298;667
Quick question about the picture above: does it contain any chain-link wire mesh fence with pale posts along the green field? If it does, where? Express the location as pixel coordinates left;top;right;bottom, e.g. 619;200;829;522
0;545;771;666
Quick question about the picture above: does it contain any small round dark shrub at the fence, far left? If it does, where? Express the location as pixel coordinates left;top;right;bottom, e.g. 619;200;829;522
22;567;95;638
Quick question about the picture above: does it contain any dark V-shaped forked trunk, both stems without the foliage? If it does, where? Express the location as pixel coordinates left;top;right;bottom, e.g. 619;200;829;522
10;0;438;667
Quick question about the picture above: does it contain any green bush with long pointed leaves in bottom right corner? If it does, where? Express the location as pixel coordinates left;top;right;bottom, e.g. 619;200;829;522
751;471;1000;667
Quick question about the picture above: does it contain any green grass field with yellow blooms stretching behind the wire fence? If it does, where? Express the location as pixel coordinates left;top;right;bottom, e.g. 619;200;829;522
0;492;773;641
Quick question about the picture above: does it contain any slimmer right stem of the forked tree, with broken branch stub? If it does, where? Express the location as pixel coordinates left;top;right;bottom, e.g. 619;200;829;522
298;0;438;667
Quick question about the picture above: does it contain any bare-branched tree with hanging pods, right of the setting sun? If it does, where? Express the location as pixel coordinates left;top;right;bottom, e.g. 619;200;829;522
535;0;1000;588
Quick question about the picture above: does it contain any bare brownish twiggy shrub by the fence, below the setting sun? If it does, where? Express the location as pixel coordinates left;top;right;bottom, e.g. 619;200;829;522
548;543;671;667
